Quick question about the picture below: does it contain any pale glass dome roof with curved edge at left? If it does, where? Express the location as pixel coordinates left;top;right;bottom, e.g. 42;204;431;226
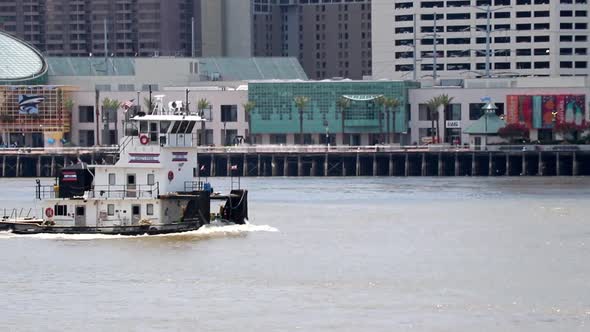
0;32;47;80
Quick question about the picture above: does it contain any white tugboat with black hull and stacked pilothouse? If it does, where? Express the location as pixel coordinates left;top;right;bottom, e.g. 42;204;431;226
0;95;248;235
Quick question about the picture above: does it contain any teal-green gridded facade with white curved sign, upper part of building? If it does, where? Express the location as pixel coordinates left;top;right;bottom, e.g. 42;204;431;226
248;81;418;134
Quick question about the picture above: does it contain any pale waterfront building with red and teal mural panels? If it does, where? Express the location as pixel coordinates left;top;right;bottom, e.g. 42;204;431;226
409;77;590;145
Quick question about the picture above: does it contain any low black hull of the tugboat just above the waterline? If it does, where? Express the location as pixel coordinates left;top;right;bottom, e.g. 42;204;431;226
0;223;202;236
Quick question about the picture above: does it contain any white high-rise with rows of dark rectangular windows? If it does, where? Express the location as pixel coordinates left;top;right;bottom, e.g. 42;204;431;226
372;0;590;79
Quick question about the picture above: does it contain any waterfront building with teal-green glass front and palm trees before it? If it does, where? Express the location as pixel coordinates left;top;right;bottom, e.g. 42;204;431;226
248;80;418;145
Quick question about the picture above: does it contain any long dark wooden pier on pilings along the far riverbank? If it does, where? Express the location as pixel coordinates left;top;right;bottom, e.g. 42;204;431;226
0;145;590;177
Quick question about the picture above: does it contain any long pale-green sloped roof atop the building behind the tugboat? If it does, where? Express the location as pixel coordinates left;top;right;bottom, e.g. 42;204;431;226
47;57;307;92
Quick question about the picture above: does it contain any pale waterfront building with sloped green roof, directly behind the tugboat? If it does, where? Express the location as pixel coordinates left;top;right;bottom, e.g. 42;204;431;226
47;57;307;146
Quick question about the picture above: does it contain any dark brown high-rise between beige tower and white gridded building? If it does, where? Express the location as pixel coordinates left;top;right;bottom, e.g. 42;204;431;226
252;0;371;79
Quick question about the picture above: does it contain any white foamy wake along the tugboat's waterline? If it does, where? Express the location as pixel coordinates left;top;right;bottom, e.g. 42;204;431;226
0;222;279;241
